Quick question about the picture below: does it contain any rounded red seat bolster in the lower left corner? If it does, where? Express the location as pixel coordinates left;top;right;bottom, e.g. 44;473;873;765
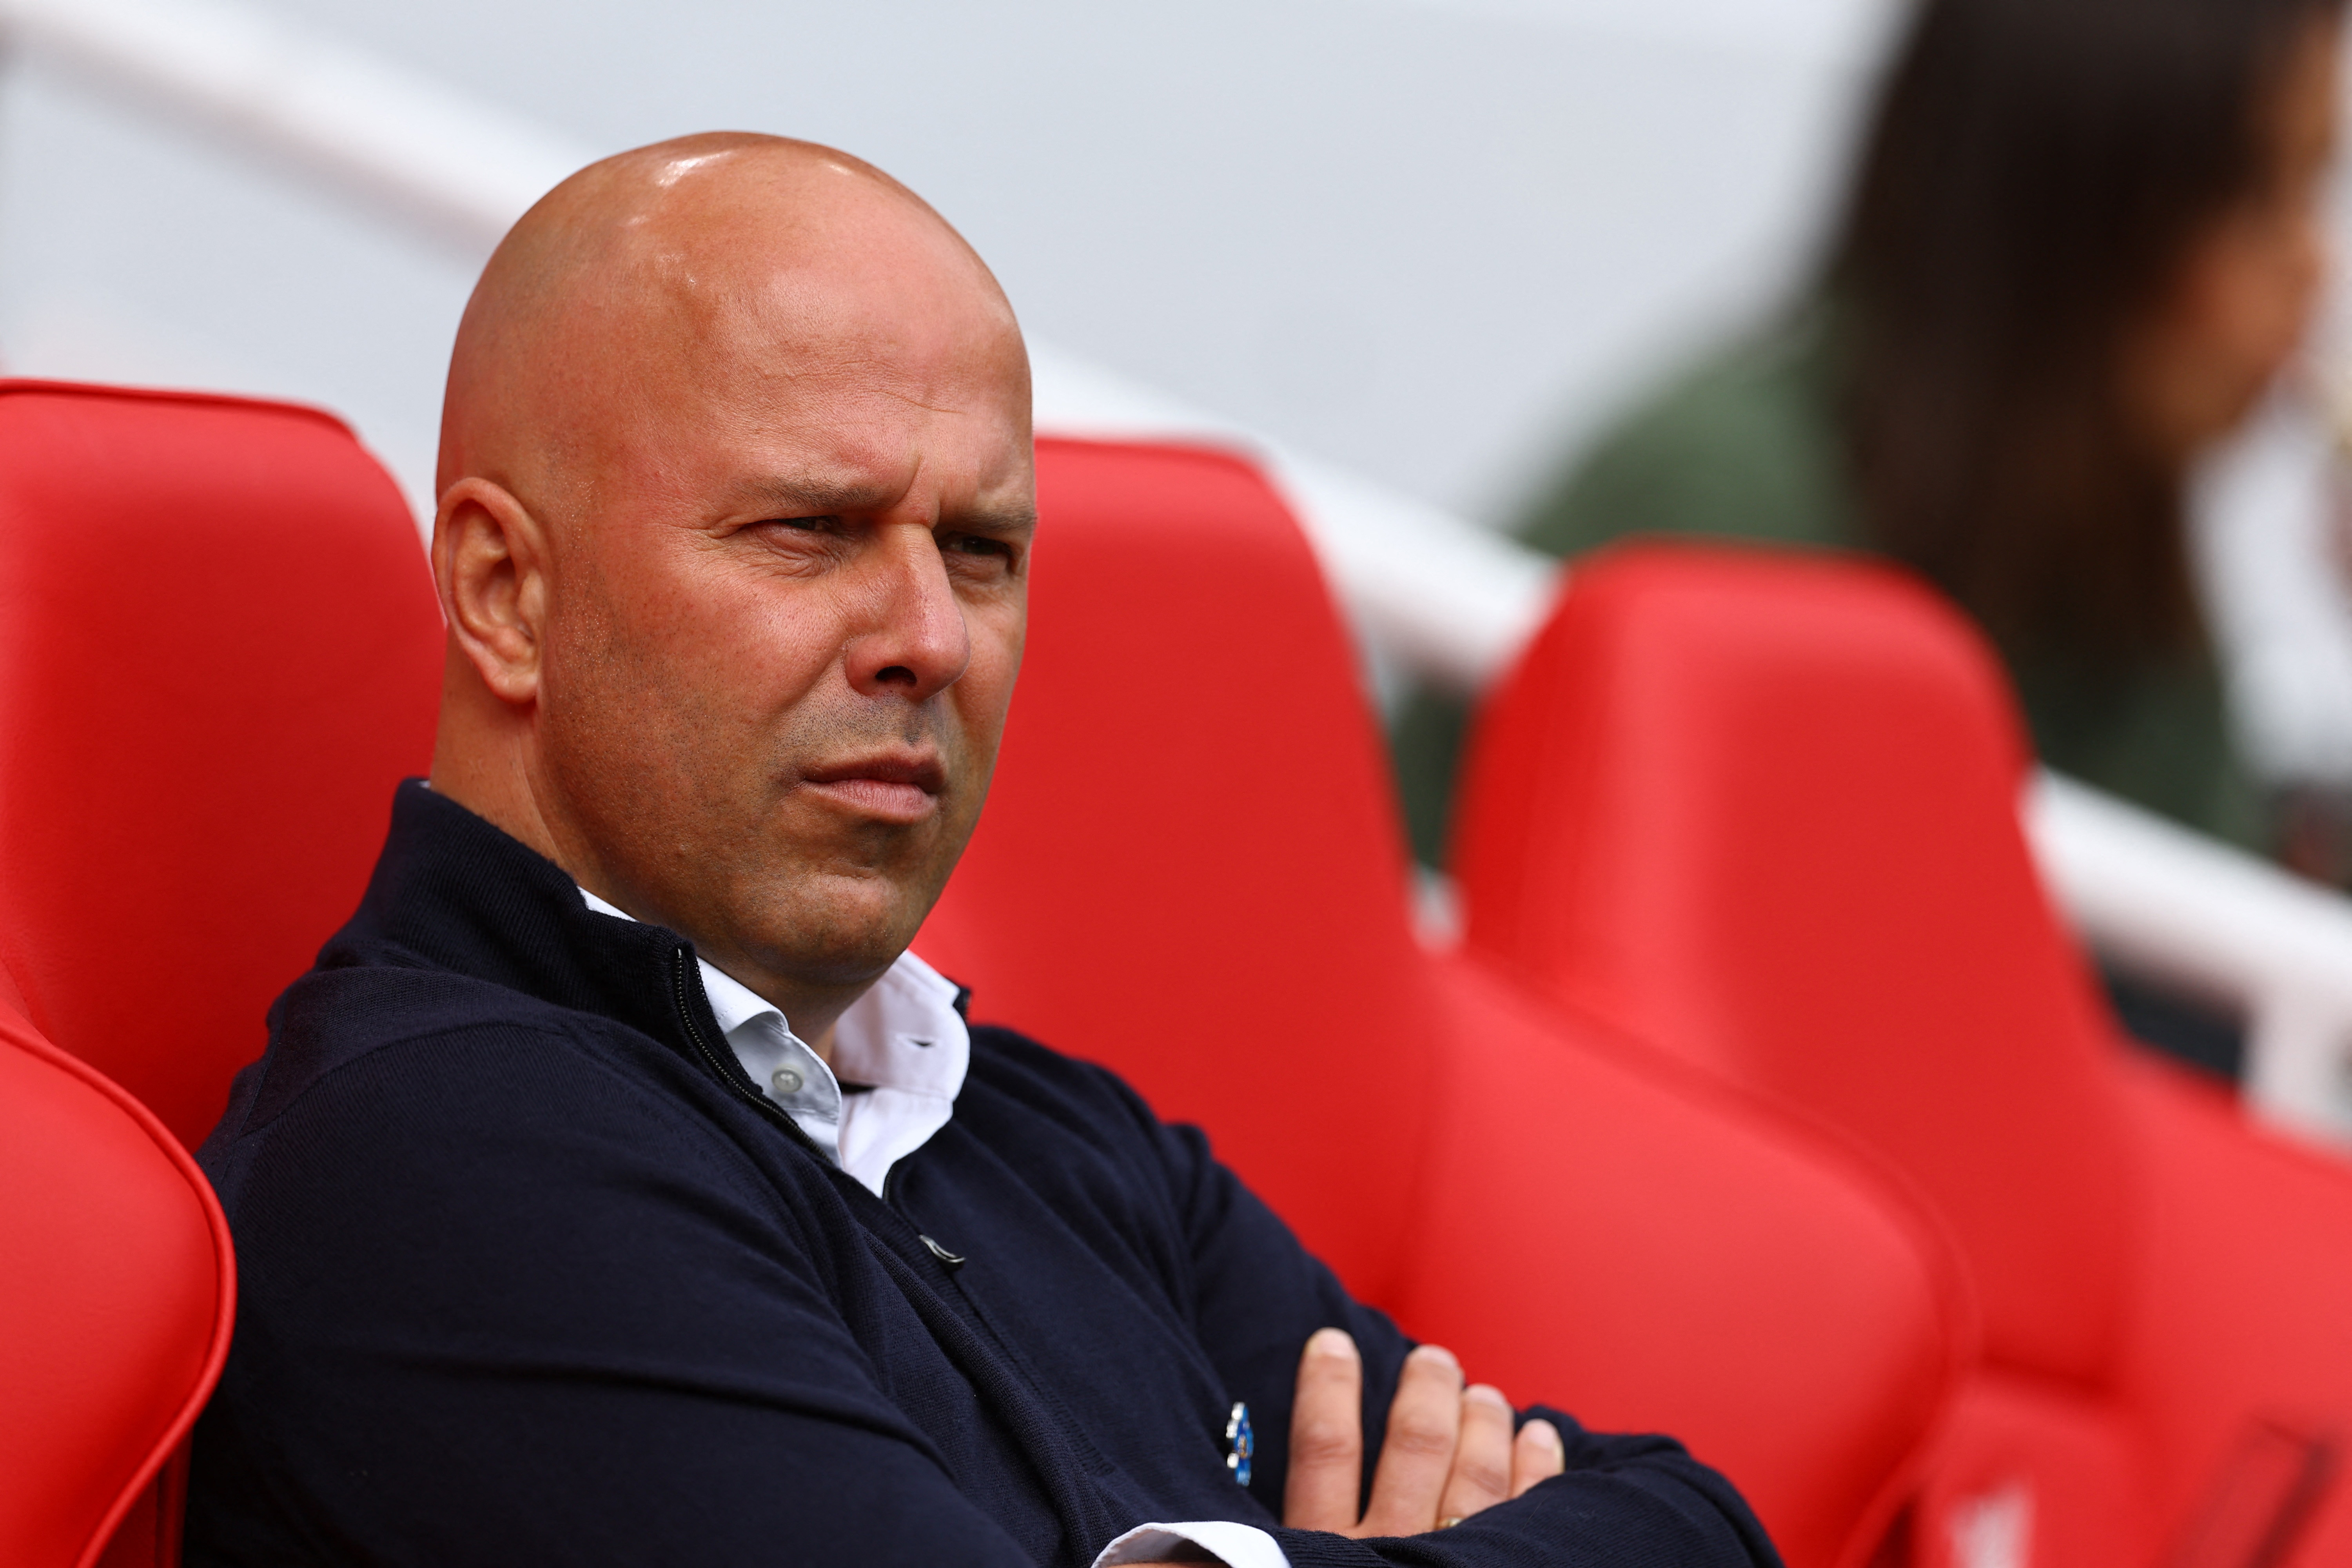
0;1009;235;1568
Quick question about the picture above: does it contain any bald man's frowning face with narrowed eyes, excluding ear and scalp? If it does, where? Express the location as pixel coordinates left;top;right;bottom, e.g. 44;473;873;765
539;222;1033;987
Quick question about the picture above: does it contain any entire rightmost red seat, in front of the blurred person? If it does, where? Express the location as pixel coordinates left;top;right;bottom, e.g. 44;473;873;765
1456;543;2352;1566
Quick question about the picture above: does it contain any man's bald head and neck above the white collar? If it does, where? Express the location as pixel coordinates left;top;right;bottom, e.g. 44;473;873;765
433;134;1035;1042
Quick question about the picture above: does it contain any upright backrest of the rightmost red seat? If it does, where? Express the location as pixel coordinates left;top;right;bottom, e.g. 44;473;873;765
1456;543;2133;1377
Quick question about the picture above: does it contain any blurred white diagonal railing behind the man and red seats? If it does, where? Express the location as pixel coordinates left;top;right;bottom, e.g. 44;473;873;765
18;0;2352;1143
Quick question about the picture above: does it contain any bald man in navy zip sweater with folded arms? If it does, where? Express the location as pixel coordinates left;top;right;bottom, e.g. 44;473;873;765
188;134;1773;1568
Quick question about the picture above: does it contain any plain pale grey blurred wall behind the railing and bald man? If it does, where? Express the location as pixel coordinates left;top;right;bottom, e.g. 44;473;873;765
0;0;1893;519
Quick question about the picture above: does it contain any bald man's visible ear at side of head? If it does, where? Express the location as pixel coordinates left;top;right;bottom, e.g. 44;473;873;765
433;479;548;703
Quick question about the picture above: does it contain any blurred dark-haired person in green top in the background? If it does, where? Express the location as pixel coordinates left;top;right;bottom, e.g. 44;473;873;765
1397;0;2343;863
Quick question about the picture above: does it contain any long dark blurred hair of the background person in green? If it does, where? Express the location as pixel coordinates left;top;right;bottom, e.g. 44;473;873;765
1825;0;2343;665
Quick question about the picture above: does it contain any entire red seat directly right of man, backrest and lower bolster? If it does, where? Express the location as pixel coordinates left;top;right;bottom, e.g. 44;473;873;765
917;439;1969;1568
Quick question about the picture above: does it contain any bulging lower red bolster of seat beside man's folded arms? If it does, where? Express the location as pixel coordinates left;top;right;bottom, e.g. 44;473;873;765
1388;955;1976;1568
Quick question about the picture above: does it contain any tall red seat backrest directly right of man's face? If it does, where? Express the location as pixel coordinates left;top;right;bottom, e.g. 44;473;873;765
915;439;1435;1293
